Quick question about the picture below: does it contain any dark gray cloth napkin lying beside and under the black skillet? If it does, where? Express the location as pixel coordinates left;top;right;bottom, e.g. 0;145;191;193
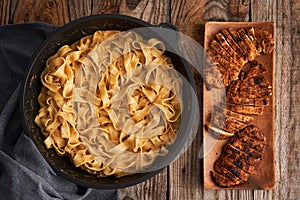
0;23;119;200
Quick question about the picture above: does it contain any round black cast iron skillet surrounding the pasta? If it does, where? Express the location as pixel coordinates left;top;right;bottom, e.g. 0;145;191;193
20;15;195;189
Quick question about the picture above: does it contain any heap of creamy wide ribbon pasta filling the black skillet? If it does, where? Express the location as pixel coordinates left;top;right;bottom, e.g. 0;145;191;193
35;31;183;177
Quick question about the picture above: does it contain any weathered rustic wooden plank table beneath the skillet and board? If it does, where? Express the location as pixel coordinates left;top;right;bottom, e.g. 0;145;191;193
0;0;300;200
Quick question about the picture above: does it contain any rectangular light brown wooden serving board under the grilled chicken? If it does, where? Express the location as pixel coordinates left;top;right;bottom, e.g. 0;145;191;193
203;22;276;190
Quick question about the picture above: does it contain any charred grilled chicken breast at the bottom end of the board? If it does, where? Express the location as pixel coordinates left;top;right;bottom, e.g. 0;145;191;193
211;125;266;187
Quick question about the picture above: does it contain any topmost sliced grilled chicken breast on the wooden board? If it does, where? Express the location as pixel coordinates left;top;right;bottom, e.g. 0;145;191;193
205;27;274;89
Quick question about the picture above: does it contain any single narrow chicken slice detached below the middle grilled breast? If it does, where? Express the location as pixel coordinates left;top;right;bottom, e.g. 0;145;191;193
226;103;263;115
